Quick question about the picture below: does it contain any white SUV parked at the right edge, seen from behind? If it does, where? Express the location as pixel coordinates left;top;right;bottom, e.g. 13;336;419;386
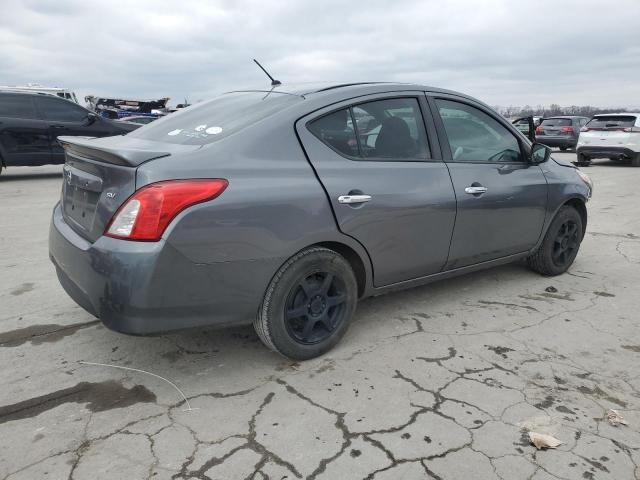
576;113;640;167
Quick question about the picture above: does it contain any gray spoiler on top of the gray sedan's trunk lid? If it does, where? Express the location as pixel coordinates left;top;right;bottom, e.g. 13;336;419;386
58;136;171;167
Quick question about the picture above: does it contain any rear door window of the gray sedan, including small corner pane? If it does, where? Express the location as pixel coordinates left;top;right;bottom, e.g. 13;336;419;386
309;98;431;161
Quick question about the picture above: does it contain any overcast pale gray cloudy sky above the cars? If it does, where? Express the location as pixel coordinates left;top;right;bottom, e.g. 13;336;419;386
0;0;640;107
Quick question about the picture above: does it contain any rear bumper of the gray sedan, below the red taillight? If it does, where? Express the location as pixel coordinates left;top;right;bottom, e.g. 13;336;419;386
49;205;272;335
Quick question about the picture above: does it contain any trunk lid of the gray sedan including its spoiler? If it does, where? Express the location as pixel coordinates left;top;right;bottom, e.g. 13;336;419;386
58;136;199;242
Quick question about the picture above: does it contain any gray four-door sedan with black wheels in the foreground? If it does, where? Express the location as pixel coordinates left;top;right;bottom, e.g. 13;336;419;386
49;83;591;359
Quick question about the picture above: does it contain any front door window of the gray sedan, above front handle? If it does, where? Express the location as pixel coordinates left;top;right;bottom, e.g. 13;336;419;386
436;99;525;163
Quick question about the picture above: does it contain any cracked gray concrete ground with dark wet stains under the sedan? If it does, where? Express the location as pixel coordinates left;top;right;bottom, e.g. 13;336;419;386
0;154;640;480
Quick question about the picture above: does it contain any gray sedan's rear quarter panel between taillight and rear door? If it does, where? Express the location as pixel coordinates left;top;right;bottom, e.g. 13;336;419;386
137;117;370;284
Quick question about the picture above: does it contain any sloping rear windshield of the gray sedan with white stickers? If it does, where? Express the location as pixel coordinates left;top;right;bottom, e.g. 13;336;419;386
128;92;302;145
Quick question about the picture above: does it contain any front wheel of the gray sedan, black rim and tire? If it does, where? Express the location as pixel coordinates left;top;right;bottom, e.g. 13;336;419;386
527;206;583;277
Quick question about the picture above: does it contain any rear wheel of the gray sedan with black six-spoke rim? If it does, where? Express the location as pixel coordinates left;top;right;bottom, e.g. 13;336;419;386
254;247;358;360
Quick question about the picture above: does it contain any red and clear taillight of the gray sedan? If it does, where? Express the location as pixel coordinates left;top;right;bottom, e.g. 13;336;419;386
105;179;229;242
